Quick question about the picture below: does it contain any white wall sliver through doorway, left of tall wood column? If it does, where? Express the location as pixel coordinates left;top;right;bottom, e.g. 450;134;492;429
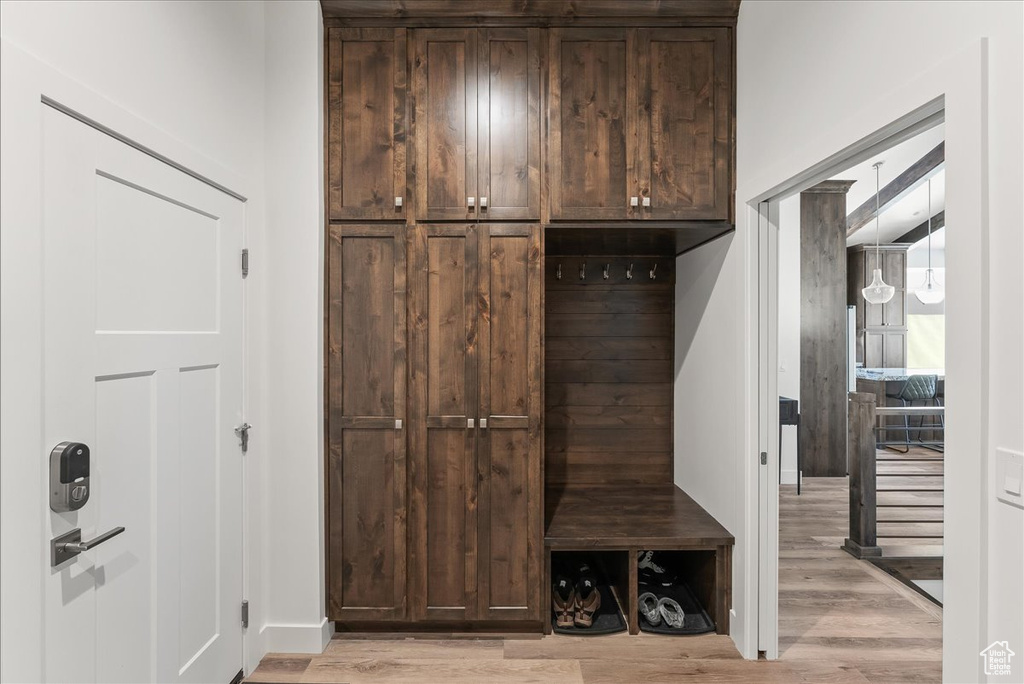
778;195;800;484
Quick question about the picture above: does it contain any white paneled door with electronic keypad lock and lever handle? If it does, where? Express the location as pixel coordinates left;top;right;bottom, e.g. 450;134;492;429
42;106;244;682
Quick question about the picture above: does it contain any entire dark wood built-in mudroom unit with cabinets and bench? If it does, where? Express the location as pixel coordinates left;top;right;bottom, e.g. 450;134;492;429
322;0;738;634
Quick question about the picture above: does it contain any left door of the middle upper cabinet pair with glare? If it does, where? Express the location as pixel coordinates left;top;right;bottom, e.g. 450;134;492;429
413;29;478;220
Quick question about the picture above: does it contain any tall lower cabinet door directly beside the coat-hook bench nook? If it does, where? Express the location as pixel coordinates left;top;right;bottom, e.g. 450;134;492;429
477;225;543;619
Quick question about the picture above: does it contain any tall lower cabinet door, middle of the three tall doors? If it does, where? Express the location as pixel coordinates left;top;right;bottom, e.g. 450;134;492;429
411;225;479;619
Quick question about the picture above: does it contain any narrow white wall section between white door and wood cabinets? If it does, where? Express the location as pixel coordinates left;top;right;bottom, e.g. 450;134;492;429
262;1;331;652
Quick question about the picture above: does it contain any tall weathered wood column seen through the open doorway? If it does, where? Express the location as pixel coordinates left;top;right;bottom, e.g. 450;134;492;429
799;180;854;477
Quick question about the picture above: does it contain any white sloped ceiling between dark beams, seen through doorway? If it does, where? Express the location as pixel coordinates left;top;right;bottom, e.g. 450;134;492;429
831;124;945;247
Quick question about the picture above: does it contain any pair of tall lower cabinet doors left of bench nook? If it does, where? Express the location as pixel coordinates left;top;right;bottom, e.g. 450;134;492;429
410;224;543;621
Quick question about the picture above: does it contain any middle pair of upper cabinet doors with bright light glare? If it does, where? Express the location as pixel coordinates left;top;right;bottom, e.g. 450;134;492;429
413;29;541;220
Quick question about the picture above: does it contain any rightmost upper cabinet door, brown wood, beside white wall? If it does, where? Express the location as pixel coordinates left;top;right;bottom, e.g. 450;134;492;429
637;29;732;220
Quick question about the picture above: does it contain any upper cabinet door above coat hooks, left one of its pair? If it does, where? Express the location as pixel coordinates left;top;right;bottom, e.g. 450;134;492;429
548;29;640;220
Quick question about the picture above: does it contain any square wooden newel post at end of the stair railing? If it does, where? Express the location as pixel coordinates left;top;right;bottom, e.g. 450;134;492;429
843;392;882;558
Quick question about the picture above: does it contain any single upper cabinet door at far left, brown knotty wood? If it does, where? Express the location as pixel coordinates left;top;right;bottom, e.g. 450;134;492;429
327;29;407;220
